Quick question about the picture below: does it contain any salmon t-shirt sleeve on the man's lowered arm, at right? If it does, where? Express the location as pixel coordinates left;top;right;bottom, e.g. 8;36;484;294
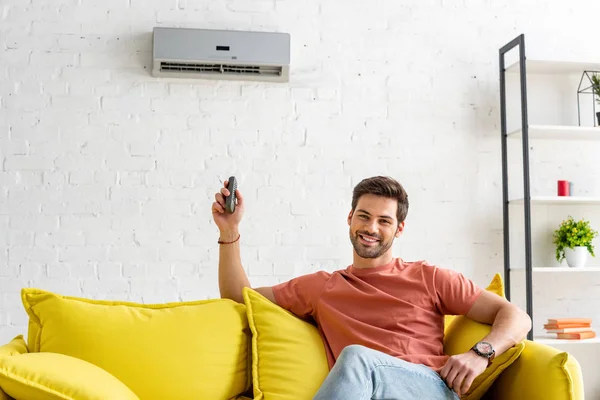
433;268;483;315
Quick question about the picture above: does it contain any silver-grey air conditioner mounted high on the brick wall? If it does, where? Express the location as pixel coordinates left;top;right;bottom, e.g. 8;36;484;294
152;27;290;82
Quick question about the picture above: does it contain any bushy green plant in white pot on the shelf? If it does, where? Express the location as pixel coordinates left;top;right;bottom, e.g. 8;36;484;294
553;216;598;267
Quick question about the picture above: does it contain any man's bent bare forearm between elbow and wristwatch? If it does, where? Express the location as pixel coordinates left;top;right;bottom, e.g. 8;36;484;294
482;305;531;355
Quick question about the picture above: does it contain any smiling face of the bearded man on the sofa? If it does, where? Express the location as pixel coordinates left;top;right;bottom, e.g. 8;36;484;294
348;194;404;258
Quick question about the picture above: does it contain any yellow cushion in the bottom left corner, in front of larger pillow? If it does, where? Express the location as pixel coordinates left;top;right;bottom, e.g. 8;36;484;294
0;353;139;400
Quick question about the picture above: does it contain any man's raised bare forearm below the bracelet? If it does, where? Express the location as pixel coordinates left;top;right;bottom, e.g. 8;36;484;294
219;230;250;303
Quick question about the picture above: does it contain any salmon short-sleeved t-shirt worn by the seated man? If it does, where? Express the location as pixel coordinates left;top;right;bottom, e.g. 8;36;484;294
273;258;482;372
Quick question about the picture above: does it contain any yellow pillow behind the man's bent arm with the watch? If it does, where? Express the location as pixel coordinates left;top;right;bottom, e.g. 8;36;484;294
444;274;525;400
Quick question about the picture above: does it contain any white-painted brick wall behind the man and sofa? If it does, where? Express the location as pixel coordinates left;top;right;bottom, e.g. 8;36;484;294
0;0;600;352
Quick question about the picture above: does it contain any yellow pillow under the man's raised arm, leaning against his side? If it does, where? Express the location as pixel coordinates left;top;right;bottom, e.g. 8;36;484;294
243;288;329;400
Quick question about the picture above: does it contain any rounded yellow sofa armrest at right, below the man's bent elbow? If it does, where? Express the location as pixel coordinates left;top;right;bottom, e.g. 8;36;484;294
485;340;584;400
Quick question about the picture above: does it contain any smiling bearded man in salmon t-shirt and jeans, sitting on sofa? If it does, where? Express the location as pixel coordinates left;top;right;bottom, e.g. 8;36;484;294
212;176;531;400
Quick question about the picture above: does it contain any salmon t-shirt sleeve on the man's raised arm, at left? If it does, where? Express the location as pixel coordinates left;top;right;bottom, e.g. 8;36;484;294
272;271;331;318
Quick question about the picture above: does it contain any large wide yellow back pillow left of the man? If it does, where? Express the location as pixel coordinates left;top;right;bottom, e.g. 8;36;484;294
22;289;250;400
